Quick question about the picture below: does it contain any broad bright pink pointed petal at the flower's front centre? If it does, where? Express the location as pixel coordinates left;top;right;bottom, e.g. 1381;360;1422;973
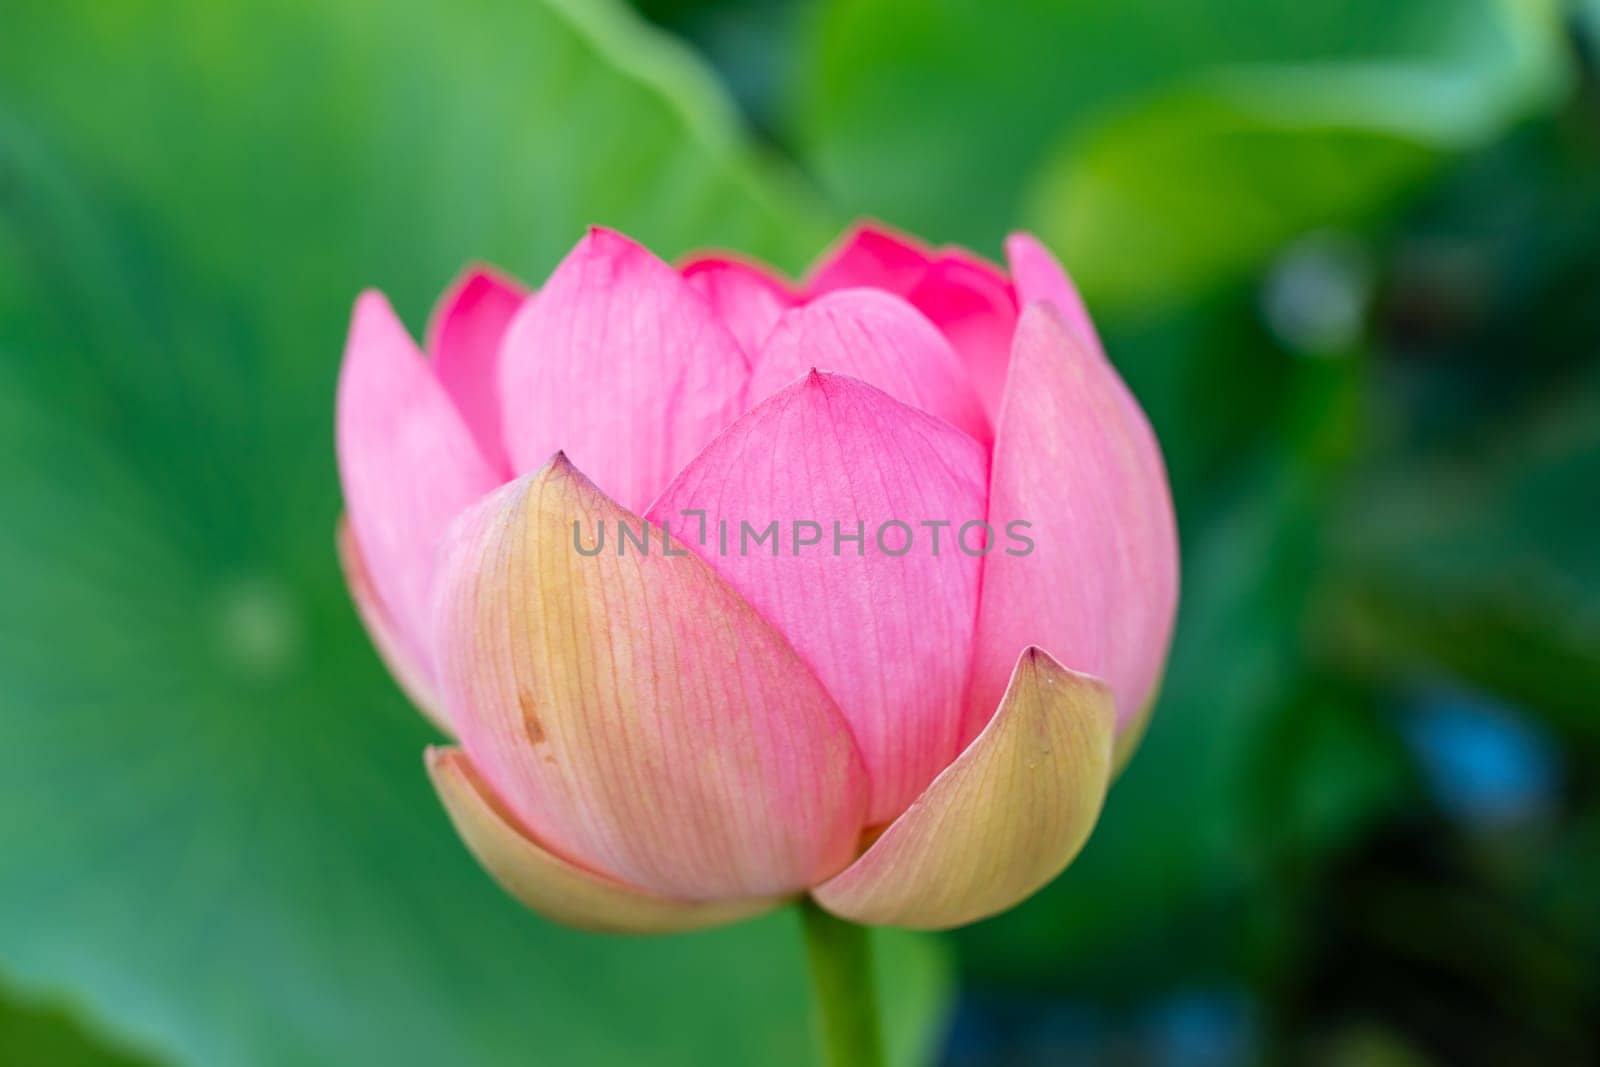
651;371;986;824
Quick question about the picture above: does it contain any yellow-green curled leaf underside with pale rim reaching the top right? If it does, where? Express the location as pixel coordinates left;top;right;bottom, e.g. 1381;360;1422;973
1027;5;1558;307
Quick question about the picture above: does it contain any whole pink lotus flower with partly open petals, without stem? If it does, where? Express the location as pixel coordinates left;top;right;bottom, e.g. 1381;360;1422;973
338;220;1178;931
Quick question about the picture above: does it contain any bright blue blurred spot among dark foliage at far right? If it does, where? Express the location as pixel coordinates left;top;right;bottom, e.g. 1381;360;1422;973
1403;688;1560;829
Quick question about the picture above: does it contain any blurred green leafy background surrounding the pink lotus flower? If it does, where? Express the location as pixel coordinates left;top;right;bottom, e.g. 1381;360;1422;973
0;0;1600;1067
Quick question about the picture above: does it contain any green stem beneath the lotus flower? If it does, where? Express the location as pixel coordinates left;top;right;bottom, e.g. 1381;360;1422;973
800;897;883;1067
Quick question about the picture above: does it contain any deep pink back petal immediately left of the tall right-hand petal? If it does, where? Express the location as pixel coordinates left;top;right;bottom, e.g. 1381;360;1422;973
910;251;1016;424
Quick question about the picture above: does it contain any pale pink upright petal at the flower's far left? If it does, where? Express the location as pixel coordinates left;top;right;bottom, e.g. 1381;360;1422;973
336;293;501;684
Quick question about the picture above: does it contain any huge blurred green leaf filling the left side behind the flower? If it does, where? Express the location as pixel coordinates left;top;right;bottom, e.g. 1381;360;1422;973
0;0;946;1064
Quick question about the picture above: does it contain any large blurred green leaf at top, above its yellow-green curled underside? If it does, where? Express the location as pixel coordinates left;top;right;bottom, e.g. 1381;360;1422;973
794;0;1565;262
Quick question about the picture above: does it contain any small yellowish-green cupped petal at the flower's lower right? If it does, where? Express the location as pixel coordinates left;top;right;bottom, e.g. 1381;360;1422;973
813;648;1112;929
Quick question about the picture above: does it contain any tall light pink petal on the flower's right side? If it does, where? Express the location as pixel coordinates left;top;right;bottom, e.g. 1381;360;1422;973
966;302;1178;734
